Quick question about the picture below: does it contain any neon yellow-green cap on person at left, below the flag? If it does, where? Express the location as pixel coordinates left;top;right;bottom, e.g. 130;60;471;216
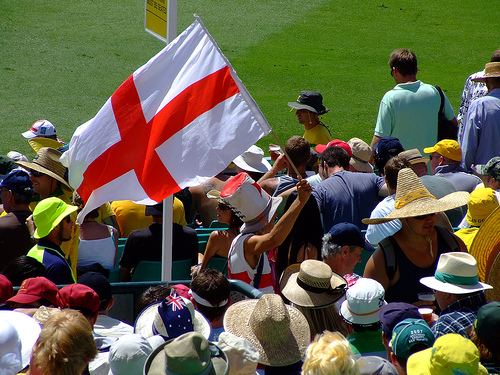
33;197;78;238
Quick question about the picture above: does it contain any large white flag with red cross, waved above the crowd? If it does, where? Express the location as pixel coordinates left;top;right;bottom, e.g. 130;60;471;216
61;16;271;222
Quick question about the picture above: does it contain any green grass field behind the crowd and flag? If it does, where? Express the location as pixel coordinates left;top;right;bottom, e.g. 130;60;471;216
0;0;500;156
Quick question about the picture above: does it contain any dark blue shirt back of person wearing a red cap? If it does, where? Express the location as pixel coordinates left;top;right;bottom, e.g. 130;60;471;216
312;171;385;233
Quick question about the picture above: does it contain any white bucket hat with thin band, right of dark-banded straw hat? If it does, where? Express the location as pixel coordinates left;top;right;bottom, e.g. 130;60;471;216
340;277;387;325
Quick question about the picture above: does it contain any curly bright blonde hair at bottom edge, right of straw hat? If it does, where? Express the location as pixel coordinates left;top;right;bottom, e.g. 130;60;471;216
302;331;360;375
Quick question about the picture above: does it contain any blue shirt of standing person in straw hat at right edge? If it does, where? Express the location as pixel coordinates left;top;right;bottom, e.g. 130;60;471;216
462;89;500;170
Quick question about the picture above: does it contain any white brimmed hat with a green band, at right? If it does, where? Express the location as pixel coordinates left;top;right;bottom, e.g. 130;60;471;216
420;252;493;294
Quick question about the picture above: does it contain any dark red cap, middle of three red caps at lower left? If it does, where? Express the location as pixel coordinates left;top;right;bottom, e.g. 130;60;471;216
6;276;59;306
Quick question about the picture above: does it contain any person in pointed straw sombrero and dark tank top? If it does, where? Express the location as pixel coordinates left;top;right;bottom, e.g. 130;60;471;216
363;168;469;306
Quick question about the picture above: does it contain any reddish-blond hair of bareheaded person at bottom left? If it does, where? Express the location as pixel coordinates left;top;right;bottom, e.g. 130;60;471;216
30;309;97;375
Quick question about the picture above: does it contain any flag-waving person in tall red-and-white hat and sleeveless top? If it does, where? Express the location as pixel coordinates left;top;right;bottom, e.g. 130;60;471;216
220;173;312;293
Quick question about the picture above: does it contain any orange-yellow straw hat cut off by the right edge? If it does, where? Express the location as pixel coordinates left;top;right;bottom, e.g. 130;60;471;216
469;208;500;281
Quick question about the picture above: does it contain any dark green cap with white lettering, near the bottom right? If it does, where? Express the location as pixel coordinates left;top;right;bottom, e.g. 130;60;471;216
389;318;435;358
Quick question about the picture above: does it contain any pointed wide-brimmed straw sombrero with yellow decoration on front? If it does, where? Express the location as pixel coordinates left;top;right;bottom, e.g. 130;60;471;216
362;168;469;224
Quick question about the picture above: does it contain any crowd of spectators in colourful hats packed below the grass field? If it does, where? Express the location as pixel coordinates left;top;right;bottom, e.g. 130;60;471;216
0;49;500;375
